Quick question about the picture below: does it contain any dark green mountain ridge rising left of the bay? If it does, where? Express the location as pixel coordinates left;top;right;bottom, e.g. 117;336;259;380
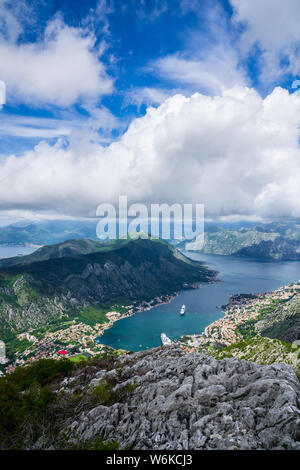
0;239;215;338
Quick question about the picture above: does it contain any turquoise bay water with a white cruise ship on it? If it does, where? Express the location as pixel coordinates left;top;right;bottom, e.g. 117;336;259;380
99;253;300;351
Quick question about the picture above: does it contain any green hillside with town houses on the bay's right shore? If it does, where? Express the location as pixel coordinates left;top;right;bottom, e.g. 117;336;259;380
181;281;300;378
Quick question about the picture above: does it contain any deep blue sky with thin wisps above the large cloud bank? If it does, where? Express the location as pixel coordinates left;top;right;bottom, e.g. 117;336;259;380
1;0;291;154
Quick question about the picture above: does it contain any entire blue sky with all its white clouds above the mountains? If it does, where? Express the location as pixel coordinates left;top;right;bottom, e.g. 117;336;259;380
0;0;300;223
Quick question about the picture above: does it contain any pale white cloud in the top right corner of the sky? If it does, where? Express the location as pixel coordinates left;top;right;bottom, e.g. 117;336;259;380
230;0;300;81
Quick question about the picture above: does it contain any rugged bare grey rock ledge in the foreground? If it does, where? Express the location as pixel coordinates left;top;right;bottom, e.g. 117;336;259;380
61;346;300;450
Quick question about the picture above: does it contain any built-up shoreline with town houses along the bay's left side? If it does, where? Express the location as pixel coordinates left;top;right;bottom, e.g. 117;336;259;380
1;250;221;372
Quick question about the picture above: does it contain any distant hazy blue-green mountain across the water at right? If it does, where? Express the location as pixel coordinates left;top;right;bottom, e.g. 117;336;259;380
180;223;300;260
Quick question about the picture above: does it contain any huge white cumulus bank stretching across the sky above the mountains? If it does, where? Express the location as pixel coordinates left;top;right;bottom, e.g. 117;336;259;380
0;87;300;217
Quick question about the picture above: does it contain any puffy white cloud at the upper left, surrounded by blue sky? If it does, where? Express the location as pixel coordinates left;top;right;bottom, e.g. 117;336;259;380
0;18;113;107
